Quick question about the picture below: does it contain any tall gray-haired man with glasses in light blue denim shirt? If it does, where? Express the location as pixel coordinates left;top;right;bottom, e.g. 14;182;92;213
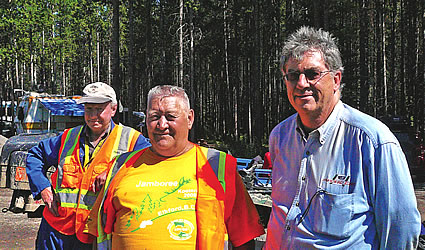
265;27;421;249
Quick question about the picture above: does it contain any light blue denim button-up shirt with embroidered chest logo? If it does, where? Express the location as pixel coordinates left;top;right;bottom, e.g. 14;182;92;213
265;101;421;249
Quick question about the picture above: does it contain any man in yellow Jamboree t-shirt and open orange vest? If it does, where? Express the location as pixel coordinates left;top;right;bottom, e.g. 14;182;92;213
87;85;264;249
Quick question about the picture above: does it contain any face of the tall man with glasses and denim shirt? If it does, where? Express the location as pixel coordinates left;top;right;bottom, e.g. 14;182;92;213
283;51;341;119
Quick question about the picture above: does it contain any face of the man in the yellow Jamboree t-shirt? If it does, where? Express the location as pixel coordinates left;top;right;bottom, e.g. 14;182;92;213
146;96;194;157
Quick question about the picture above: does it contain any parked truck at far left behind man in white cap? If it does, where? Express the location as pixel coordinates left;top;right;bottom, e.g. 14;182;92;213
0;92;84;216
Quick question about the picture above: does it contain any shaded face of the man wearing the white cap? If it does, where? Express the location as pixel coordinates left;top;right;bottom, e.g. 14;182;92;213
84;102;117;135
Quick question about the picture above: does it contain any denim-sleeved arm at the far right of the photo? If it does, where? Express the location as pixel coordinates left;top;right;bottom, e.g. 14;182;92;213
371;143;421;249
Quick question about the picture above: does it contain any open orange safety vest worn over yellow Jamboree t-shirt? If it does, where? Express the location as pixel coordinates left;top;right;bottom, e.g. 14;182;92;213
91;144;237;249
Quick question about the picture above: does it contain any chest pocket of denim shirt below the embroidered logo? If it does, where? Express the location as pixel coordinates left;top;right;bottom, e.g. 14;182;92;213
306;192;355;239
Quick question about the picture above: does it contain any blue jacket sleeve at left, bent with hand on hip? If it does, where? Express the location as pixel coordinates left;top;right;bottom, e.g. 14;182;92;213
26;135;61;199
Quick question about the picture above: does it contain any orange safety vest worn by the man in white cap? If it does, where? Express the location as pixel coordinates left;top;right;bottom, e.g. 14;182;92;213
43;125;140;243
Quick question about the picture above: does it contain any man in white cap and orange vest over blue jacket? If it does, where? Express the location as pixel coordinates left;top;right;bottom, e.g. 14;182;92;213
26;82;150;249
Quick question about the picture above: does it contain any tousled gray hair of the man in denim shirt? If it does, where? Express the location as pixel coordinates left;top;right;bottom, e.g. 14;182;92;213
280;26;344;72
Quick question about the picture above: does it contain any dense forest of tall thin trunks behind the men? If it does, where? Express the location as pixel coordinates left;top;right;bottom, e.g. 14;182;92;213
0;0;425;157
